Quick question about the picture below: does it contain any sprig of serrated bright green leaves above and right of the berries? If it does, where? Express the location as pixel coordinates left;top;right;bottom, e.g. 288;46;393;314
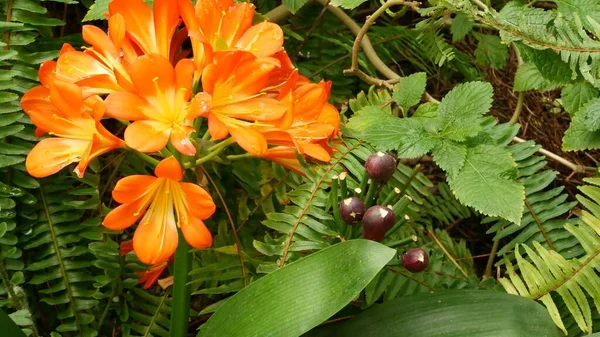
347;82;525;224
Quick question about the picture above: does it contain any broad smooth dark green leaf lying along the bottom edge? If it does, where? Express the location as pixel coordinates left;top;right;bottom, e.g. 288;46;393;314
305;290;562;337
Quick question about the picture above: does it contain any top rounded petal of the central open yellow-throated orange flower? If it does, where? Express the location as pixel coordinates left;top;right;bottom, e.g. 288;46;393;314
129;53;175;98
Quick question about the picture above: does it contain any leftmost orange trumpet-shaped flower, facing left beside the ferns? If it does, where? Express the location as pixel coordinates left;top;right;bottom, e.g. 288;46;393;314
21;82;125;178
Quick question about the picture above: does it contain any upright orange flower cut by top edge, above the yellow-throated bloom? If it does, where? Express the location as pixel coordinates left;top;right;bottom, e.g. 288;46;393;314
108;0;180;60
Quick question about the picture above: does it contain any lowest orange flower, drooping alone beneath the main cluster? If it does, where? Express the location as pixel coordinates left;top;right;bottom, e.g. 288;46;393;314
103;157;215;264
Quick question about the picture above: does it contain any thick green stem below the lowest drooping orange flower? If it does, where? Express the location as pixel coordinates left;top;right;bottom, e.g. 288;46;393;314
170;231;192;337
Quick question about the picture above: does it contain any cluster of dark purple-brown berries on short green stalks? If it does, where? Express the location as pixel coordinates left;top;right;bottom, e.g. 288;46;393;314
334;152;429;273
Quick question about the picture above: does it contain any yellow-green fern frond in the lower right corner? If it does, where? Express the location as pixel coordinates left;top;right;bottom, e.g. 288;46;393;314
500;178;600;334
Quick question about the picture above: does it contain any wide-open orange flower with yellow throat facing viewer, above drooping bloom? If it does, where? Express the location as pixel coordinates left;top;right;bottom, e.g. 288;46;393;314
106;54;199;156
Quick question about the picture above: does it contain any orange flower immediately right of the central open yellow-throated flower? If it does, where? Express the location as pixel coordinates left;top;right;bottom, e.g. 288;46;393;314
192;51;287;155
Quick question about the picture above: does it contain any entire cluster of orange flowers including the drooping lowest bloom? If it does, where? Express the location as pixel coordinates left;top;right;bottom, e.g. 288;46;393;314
21;0;340;264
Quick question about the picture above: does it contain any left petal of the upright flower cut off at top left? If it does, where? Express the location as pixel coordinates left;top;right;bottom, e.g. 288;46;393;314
108;0;157;56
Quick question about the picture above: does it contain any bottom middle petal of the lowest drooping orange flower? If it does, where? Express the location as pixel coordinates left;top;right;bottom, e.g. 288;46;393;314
133;204;179;264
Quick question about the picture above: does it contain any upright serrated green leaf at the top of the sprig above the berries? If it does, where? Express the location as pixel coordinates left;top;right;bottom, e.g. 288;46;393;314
437;82;493;142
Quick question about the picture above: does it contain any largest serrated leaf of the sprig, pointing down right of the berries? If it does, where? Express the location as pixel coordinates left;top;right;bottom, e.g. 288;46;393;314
448;145;525;224
